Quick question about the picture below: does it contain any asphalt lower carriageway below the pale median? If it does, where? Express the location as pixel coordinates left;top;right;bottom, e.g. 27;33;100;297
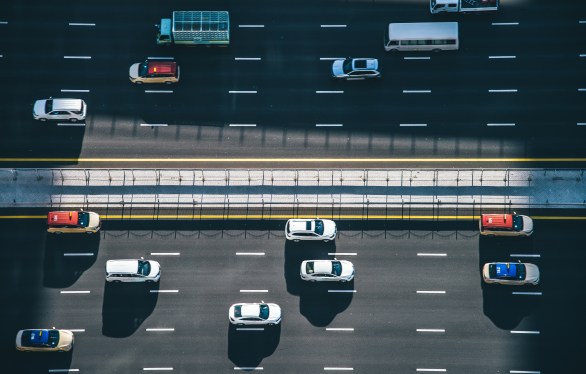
0;220;586;373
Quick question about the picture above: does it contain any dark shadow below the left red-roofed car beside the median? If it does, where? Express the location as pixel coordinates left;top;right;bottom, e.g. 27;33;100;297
43;234;100;288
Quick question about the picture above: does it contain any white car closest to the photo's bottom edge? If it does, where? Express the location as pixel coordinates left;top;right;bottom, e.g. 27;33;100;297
228;301;281;326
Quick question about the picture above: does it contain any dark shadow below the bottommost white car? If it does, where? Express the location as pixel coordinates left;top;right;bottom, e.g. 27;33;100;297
228;323;281;368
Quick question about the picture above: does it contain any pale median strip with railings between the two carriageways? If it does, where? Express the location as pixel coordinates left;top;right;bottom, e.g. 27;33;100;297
0;169;586;219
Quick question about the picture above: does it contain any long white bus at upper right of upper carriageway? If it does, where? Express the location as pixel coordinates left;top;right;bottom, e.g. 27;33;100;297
385;22;460;51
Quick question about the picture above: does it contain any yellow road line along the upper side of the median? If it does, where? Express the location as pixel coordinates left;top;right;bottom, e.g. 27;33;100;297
0;157;586;164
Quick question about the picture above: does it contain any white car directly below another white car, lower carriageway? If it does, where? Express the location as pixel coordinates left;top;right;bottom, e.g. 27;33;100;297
299;260;354;282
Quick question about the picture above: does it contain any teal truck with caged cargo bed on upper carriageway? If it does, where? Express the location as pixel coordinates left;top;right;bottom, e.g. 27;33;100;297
155;10;230;46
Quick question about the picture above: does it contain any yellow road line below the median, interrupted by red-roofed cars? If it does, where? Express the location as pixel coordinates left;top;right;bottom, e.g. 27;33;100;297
0;214;586;221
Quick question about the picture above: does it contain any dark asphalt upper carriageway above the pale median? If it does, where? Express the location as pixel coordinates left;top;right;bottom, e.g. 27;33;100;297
0;0;586;167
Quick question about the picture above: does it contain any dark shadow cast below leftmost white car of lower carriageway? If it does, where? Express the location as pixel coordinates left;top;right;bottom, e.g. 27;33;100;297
102;282;159;338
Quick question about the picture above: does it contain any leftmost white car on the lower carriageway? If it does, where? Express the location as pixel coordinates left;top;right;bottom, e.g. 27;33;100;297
106;258;161;283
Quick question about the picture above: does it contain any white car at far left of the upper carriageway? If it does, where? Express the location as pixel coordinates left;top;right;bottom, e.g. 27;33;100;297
33;98;87;122
